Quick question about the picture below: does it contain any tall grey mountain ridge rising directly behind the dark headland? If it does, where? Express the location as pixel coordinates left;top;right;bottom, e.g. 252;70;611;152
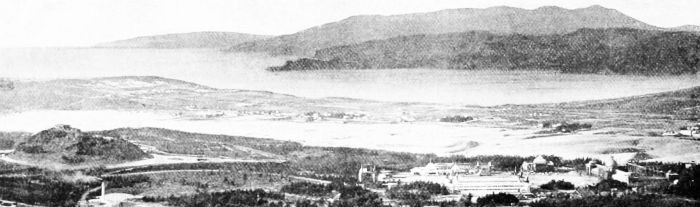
230;6;657;56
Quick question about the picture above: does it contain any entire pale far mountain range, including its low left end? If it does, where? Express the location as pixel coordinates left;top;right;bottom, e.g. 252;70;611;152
97;5;700;67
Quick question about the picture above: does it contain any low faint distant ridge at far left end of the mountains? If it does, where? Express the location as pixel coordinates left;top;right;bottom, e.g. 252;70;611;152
96;32;270;49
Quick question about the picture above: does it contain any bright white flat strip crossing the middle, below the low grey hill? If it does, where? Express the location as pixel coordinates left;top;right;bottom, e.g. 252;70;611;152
0;107;700;161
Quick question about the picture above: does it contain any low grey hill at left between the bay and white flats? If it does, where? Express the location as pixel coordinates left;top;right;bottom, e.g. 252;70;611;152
0;76;314;112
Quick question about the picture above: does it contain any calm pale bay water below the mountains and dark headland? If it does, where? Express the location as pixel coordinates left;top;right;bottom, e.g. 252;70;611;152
0;48;700;105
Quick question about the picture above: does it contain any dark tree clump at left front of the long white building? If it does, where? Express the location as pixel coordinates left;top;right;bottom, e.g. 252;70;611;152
386;181;450;202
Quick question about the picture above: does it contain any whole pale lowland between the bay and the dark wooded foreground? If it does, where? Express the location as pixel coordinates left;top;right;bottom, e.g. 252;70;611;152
0;77;700;165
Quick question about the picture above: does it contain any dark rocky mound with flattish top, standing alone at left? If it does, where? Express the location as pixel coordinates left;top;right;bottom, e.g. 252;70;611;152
13;125;148;164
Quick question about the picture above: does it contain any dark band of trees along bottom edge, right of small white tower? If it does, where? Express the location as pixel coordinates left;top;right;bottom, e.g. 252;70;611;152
143;189;284;207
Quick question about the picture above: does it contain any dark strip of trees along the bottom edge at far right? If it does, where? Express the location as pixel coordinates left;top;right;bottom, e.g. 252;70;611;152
530;194;700;207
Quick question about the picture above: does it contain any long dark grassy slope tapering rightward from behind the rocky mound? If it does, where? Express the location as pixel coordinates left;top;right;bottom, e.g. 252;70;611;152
94;128;427;175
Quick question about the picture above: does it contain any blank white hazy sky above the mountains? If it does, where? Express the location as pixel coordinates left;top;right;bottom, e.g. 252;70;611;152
0;0;700;47
